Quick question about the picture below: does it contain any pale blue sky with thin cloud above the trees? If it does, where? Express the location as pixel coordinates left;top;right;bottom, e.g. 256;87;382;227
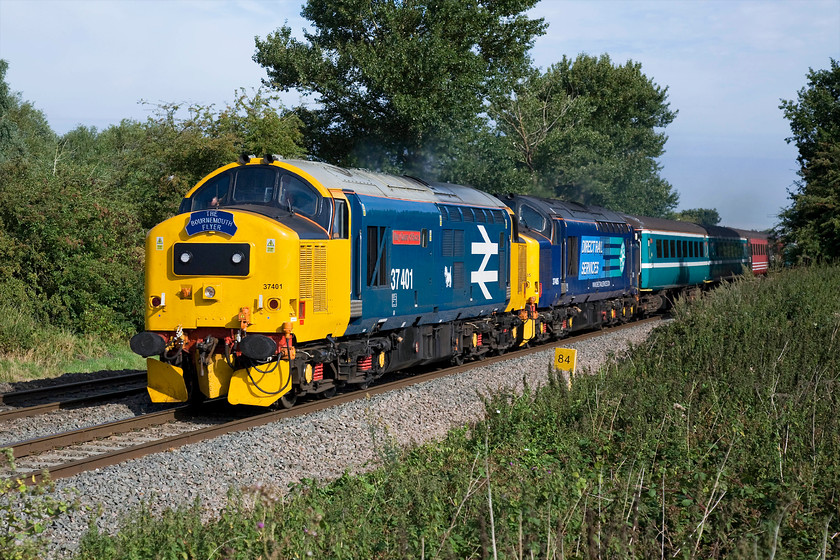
0;0;840;229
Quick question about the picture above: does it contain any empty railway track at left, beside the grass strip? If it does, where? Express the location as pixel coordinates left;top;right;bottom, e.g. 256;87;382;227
0;372;146;421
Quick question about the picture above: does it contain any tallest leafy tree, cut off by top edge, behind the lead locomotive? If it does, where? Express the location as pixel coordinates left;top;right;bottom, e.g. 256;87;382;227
254;0;545;176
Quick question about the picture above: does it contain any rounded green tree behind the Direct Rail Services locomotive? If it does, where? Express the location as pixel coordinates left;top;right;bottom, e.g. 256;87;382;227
452;54;678;216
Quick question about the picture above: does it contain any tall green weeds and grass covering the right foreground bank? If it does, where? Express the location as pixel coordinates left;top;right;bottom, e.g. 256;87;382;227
67;267;840;560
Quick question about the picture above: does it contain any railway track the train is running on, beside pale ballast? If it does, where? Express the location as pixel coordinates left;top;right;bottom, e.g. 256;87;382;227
0;317;661;481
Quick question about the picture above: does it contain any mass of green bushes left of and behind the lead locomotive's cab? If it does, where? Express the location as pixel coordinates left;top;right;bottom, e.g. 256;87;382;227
0;60;303;354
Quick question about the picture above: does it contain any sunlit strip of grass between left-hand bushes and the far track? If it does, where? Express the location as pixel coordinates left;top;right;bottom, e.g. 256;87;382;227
0;307;145;383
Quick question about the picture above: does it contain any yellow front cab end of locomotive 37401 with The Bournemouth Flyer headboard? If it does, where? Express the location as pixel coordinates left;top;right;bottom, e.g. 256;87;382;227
131;158;349;406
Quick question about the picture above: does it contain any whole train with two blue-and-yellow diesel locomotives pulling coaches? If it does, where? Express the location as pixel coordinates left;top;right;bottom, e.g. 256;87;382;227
131;156;750;407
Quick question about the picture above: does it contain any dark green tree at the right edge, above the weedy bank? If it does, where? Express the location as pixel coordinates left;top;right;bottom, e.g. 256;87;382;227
776;59;840;261
